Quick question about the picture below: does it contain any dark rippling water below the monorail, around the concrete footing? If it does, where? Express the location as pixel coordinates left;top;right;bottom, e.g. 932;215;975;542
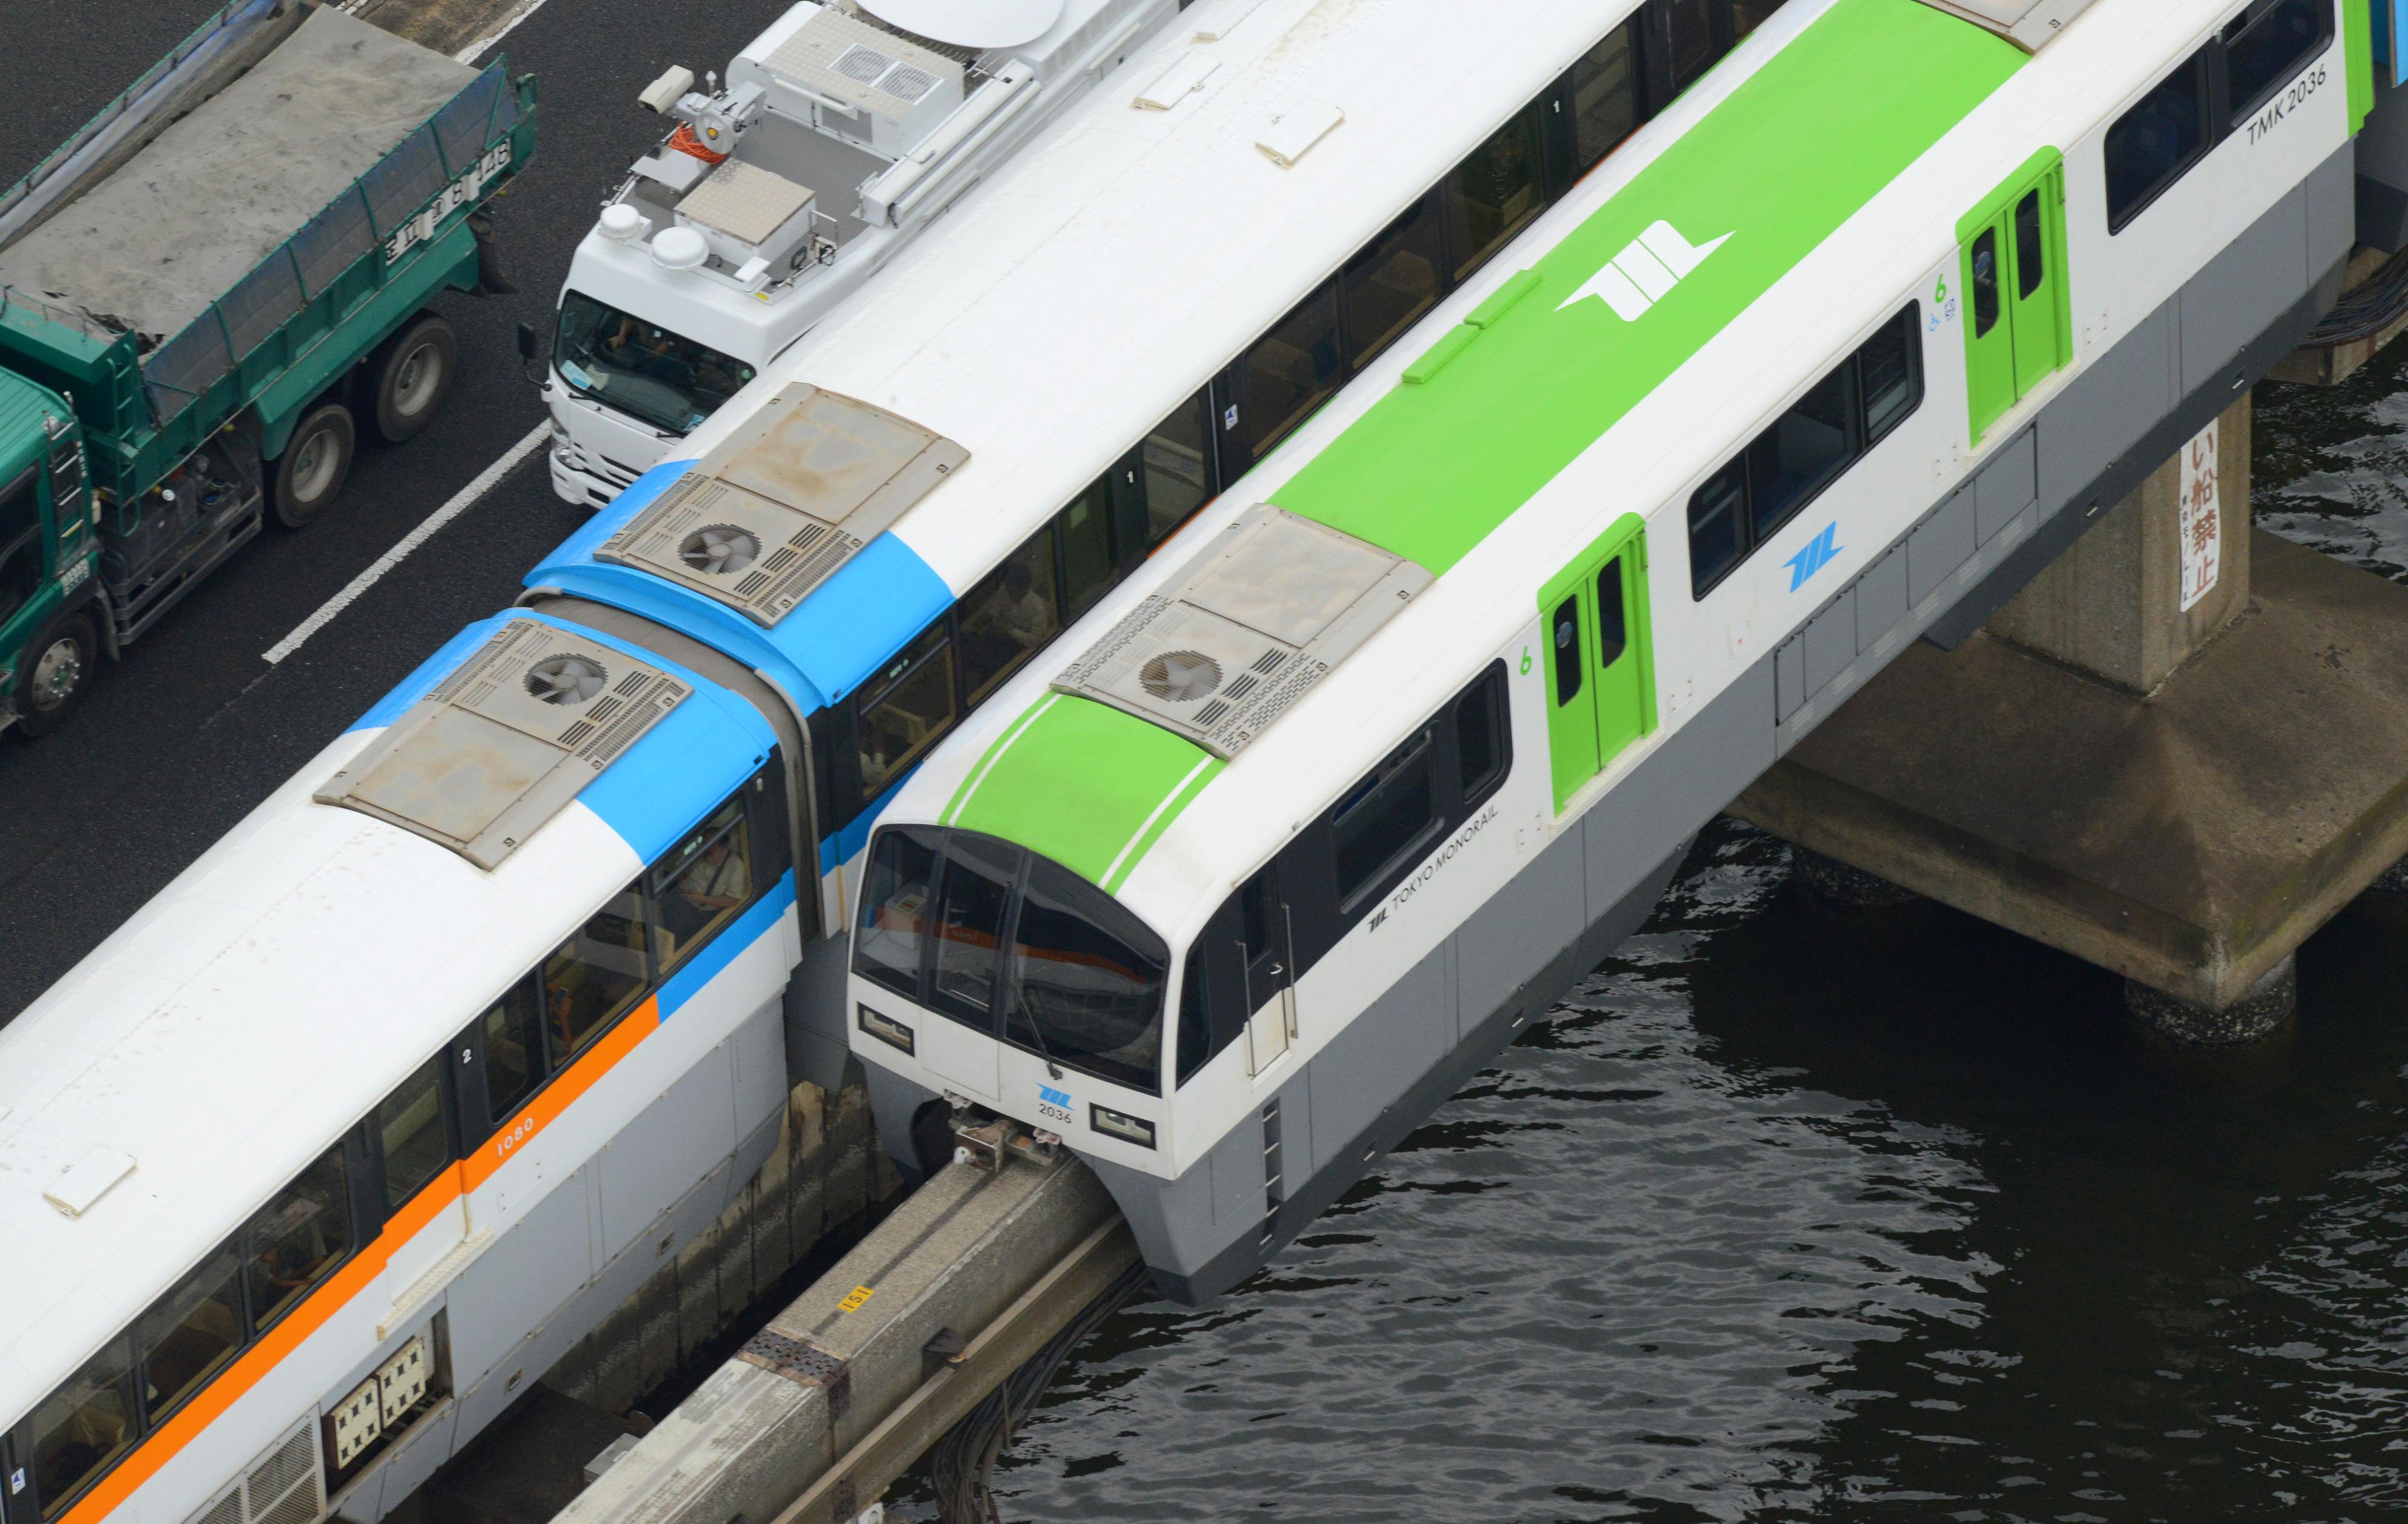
903;371;2408;1524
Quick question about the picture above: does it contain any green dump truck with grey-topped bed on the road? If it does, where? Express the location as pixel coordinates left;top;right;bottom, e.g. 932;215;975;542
0;0;535;734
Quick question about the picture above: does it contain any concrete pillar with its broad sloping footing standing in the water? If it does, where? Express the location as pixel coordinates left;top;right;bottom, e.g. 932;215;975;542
1731;385;2408;1042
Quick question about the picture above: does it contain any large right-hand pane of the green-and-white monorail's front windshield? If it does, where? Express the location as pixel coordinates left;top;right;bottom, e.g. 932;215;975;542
1001;845;1170;1096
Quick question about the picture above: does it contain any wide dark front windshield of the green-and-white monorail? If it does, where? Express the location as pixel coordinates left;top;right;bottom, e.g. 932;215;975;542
853;826;1170;1096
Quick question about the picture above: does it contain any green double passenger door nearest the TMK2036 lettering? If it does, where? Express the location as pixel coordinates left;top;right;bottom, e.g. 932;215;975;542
1958;149;2073;443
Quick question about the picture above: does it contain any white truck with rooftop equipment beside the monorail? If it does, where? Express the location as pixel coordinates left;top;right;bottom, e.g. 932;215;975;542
549;0;1182;508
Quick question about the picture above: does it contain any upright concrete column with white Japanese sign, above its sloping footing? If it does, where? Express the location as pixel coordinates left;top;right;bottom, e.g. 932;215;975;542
1989;395;2251;696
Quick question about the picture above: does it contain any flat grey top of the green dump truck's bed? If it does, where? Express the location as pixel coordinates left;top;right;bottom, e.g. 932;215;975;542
0;7;477;351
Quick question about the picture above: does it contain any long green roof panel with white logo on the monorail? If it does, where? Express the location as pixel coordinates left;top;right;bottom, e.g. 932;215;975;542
1271;0;2023;573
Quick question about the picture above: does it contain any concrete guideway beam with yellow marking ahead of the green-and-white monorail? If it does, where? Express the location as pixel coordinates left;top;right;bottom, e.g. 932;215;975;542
559;1156;1137;1524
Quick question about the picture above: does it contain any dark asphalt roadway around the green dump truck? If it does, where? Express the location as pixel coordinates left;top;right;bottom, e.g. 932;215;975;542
0;0;785;1021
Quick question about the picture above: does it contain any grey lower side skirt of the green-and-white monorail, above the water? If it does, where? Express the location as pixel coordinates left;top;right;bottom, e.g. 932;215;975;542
1089;147;2355;1305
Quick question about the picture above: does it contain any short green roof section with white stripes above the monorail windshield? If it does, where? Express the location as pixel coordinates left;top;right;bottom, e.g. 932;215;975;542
941;693;1223;891
